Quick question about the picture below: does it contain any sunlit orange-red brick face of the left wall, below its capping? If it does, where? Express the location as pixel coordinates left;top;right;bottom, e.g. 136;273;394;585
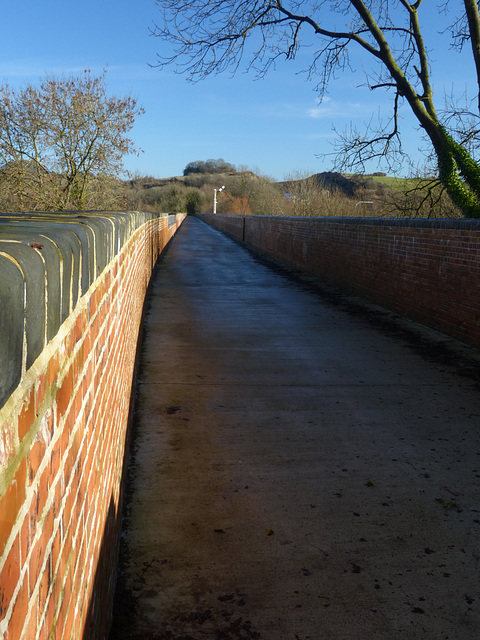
0;214;183;640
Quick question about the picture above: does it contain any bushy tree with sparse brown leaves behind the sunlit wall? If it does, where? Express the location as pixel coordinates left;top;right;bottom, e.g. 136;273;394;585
0;71;143;210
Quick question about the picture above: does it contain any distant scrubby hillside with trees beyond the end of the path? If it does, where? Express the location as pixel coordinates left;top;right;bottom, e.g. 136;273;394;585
127;160;461;218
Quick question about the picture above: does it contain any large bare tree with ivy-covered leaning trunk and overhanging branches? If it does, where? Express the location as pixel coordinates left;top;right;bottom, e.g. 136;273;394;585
154;0;480;217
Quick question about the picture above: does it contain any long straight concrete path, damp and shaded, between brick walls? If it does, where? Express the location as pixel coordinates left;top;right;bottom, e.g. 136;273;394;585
112;218;480;640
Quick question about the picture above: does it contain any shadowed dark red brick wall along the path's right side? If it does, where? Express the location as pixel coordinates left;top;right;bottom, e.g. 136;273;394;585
201;214;480;348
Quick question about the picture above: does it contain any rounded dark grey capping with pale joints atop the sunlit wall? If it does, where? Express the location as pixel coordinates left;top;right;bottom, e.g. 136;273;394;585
0;212;163;407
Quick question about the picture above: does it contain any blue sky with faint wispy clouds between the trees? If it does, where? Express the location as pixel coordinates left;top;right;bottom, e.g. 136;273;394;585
0;0;473;180
